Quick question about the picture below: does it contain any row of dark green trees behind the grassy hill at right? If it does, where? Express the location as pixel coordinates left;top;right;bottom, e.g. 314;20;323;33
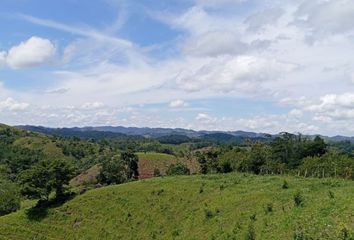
196;133;354;179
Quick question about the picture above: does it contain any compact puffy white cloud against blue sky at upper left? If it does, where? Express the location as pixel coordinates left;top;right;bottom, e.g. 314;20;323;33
0;37;56;69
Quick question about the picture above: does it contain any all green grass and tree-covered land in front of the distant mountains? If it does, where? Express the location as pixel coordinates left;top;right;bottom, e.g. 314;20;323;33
0;125;354;240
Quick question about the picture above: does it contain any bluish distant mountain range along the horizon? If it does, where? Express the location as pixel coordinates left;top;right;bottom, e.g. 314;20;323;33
16;125;354;143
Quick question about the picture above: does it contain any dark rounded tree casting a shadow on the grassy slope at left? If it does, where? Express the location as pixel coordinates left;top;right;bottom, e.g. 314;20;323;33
20;159;74;200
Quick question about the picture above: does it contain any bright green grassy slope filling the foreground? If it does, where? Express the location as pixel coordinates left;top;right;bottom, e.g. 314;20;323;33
0;174;354;240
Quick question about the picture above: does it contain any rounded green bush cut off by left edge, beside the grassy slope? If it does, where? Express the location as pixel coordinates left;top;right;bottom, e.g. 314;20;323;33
0;180;21;216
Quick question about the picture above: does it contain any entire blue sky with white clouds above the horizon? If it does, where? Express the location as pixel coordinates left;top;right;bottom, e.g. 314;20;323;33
0;0;354;136
